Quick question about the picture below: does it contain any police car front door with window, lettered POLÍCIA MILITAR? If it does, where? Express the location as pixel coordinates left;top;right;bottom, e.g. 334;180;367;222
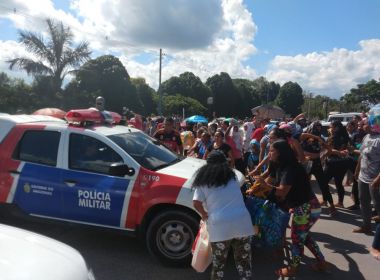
58;133;135;227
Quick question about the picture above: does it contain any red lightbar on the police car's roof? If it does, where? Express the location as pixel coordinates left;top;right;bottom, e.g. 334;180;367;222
65;108;121;126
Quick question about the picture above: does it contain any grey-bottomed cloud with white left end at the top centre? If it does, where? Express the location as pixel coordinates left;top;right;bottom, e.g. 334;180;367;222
72;0;223;49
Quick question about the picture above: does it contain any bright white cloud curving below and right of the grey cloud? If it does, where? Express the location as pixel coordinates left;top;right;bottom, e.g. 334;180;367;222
122;0;257;88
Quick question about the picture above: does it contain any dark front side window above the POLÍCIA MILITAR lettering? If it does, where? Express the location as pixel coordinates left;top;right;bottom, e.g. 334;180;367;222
69;133;123;174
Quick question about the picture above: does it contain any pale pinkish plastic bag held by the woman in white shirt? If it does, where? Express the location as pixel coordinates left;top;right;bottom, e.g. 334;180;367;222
191;220;212;272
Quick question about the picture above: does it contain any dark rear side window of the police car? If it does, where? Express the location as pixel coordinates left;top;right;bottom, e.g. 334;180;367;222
13;130;61;166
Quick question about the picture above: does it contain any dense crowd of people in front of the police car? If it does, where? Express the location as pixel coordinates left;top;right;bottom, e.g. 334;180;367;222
128;105;380;279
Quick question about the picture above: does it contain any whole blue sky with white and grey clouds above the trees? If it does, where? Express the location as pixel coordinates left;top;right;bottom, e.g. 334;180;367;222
0;0;380;98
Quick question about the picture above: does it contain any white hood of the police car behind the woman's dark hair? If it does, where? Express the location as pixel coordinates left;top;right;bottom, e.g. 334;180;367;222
159;157;244;187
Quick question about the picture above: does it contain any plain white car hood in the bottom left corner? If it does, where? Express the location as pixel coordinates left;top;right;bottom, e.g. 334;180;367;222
0;224;93;280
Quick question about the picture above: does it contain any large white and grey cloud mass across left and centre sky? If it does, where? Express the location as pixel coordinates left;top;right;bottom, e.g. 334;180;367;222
0;0;257;88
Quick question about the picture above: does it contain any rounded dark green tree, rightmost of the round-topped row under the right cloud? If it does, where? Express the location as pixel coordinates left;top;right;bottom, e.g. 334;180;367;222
275;82;304;117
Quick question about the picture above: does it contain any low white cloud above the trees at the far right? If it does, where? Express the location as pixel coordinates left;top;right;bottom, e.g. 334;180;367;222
267;39;380;98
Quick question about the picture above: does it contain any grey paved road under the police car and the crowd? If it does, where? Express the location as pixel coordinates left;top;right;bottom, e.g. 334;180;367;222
0;180;380;280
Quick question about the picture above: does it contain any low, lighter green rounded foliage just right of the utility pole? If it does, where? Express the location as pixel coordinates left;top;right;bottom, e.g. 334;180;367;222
162;94;207;116
